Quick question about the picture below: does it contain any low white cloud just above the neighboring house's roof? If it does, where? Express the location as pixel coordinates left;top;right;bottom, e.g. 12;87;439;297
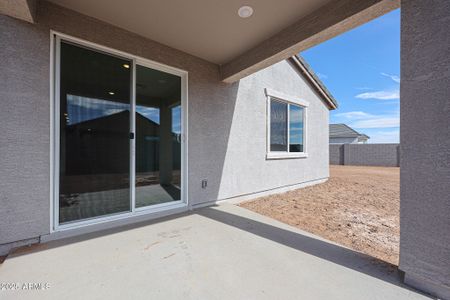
334;111;400;129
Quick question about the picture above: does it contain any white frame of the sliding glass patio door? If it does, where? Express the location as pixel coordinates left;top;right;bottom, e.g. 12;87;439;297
50;30;188;233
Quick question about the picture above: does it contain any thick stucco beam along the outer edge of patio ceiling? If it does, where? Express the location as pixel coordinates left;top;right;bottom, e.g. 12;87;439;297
220;0;400;83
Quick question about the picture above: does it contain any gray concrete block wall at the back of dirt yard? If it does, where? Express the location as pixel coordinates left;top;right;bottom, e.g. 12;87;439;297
330;144;400;167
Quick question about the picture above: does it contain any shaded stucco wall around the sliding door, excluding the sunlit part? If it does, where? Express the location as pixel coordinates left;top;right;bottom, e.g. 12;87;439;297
0;1;225;244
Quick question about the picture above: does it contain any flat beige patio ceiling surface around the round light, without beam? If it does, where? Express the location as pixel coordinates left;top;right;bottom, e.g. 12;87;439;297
47;0;331;65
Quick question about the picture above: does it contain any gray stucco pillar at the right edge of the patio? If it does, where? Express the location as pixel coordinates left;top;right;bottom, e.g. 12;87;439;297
400;0;450;299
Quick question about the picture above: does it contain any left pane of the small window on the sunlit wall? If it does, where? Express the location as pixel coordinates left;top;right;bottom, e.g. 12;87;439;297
270;100;287;151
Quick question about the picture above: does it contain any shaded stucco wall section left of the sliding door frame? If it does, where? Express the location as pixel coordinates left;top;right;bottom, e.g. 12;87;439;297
0;15;50;244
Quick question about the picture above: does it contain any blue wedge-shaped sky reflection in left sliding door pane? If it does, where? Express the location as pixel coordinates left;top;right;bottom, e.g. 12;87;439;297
67;94;130;125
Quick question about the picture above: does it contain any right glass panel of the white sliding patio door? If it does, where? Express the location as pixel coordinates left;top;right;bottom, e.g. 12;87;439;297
135;65;181;208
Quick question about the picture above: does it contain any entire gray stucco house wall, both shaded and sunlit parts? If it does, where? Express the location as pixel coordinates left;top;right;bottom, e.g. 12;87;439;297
0;1;328;244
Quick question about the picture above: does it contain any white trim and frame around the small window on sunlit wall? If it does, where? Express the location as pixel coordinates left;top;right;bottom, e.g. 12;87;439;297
264;88;309;159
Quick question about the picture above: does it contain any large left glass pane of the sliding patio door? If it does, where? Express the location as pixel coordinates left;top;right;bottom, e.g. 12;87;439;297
59;42;131;223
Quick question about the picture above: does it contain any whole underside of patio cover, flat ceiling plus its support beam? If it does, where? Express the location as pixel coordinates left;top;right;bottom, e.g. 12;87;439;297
0;0;400;82
